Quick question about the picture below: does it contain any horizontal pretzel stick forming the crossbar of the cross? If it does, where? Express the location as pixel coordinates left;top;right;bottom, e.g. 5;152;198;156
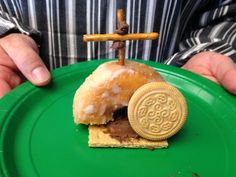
83;33;158;42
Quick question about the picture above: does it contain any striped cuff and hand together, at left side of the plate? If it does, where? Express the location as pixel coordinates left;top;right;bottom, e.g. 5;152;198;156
0;11;50;98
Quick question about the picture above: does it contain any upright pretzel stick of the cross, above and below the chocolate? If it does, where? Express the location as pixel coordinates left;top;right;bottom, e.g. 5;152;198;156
117;9;125;65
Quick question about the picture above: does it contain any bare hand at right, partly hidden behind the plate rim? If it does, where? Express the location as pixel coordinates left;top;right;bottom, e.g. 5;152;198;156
182;52;236;94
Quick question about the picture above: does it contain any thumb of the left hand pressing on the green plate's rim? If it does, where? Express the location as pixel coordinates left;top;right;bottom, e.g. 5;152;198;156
1;38;51;86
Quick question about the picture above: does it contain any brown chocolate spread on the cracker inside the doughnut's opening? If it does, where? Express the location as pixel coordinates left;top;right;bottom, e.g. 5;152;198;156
104;107;140;142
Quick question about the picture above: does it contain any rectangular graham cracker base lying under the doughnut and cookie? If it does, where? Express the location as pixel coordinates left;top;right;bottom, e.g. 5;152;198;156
88;125;168;149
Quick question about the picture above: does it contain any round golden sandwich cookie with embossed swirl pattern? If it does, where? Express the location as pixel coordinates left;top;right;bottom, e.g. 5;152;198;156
128;82;187;140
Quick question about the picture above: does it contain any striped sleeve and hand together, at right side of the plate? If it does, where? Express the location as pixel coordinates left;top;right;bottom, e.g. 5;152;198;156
166;4;236;94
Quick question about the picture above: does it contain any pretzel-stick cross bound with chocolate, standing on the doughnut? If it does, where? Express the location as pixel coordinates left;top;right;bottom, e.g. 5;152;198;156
83;9;158;65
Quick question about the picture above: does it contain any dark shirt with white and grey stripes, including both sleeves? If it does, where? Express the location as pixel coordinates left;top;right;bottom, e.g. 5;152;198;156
0;0;236;69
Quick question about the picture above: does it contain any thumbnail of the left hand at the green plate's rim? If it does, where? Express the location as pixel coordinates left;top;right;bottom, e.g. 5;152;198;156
32;66;50;84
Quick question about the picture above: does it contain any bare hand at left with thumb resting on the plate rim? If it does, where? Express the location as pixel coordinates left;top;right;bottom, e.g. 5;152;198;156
0;33;51;98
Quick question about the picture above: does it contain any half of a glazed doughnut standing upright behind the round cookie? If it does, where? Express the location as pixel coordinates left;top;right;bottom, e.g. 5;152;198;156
73;60;164;124
